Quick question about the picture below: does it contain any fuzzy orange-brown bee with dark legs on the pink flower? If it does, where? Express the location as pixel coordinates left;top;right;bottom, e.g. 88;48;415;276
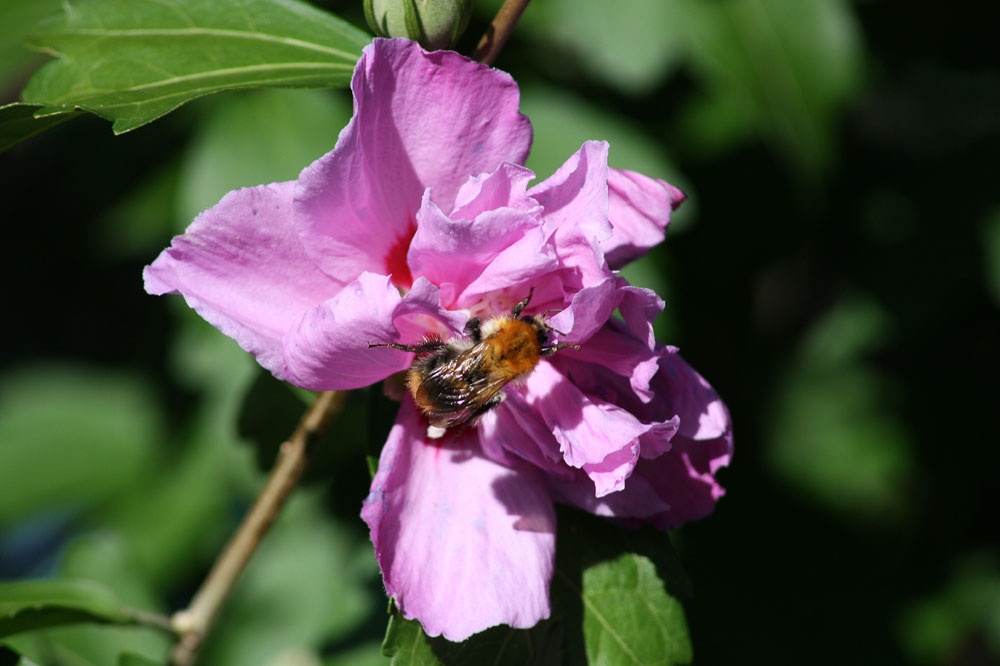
368;289;580;432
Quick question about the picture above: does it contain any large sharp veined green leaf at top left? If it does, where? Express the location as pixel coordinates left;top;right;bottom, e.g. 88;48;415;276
24;0;369;134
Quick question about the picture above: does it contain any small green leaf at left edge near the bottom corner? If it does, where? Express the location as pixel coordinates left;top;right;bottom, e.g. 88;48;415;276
0;579;136;637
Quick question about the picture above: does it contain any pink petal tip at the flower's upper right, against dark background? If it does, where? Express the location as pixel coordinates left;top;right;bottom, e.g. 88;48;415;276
601;169;685;269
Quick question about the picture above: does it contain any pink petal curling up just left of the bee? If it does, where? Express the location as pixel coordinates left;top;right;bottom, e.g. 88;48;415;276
282;273;466;391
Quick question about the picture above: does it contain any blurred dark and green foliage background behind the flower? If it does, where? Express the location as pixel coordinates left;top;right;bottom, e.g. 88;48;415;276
0;0;1000;666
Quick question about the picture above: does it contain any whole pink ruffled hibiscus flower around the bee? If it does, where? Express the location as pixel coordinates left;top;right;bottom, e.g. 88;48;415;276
144;39;732;640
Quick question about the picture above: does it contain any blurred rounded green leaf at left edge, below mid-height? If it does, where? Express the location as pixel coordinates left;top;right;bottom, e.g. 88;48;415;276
0;366;160;525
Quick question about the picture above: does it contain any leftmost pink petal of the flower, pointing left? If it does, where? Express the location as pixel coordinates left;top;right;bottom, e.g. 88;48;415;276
143;183;339;376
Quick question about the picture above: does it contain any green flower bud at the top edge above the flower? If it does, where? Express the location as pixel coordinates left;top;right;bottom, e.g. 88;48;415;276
364;0;472;50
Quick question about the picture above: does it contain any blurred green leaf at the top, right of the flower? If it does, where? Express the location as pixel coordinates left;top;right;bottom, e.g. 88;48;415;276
677;0;862;174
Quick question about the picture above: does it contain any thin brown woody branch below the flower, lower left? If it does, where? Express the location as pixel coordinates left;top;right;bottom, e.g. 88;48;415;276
170;391;347;666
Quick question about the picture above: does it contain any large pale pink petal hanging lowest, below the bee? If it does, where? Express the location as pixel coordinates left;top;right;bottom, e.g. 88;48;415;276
361;400;555;641
